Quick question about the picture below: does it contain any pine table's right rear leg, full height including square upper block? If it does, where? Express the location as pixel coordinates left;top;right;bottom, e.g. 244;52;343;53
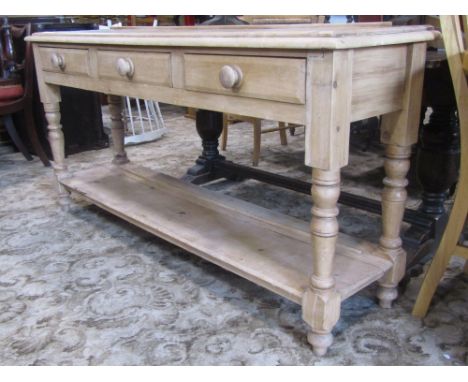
377;43;426;308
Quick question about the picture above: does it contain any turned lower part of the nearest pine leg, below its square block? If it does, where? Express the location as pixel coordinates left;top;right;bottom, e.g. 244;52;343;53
302;168;341;356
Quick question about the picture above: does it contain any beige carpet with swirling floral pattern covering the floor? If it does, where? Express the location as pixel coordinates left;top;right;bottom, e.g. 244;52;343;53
0;104;468;365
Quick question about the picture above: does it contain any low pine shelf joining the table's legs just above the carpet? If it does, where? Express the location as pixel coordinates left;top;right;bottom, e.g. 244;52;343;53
61;164;392;304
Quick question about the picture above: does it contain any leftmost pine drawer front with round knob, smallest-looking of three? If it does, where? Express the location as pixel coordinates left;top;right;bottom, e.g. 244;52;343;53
39;47;89;76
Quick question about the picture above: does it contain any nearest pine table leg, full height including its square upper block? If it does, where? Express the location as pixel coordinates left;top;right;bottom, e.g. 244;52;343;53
302;50;353;355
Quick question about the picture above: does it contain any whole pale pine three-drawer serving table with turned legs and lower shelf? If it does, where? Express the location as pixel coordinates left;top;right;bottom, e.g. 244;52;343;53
30;25;438;355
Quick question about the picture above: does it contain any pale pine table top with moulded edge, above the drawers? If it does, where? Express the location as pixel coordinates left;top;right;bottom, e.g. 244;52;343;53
27;23;440;49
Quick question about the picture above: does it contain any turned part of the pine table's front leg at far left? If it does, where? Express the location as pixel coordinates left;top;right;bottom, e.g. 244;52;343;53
44;102;70;206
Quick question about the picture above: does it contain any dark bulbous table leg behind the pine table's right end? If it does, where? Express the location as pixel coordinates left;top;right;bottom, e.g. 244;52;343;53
405;54;460;251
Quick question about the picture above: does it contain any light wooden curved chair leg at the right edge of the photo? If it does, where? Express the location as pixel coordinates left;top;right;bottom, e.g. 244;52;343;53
413;16;468;317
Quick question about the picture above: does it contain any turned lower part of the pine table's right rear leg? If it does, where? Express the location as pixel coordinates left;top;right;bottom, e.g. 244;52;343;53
377;144;411;308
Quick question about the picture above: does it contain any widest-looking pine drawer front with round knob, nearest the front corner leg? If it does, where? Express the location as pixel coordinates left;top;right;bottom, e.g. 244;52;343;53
184;54;306;104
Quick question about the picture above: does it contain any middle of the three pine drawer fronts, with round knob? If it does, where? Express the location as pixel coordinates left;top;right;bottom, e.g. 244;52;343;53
97;50;172;86
